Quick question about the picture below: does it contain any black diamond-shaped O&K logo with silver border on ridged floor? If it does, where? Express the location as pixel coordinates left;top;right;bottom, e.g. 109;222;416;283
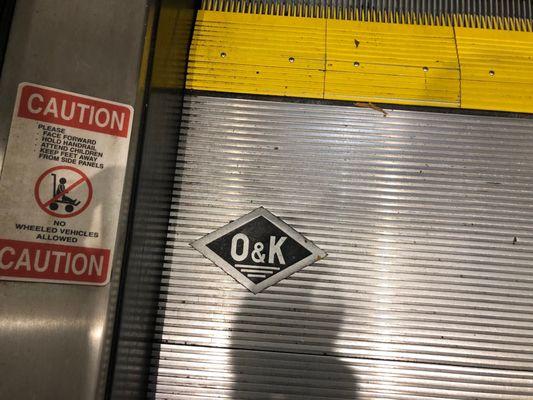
191;207;326;293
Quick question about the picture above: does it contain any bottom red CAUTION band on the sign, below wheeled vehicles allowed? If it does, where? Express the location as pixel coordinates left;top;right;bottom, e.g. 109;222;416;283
0;239;110;284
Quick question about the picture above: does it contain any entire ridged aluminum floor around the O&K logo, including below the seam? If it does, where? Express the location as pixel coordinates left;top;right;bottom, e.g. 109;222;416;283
151;95;533;399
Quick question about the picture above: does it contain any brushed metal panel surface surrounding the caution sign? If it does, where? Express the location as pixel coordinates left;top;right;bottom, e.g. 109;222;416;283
0;0;153;400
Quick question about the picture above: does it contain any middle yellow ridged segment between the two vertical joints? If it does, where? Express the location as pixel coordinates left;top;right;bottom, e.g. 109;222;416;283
324;20;460;107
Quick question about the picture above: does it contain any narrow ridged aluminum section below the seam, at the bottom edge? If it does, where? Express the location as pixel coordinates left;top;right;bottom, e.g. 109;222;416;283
151;345;533;400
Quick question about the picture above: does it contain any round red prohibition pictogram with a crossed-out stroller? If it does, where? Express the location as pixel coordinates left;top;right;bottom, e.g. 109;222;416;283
35;165;93;218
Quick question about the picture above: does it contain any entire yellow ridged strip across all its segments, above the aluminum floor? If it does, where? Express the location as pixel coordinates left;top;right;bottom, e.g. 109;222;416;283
187;10;533;112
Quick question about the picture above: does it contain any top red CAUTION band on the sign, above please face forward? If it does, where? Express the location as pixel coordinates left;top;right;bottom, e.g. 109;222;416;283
17;84;133;138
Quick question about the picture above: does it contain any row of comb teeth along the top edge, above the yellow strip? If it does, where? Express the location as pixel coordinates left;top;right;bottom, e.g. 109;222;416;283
202;0;533;32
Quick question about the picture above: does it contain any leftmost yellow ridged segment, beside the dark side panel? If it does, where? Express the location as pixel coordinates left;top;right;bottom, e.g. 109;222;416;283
187;11;326;98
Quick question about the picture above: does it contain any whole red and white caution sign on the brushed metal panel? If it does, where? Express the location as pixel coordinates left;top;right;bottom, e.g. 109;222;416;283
0;83;133;285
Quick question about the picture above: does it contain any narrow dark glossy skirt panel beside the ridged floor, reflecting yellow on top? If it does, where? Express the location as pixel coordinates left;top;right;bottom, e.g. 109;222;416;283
108;0;195;400
